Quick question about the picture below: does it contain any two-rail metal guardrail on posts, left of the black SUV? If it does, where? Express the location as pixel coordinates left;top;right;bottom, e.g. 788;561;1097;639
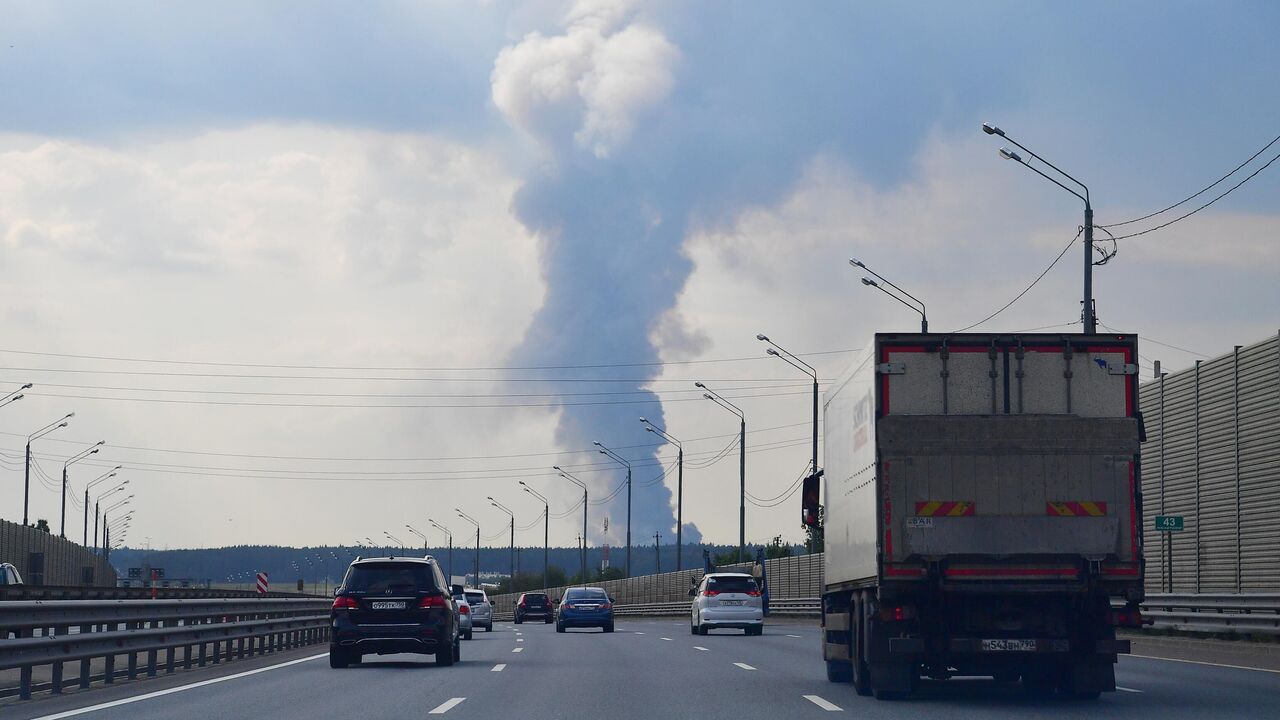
0;598;332;700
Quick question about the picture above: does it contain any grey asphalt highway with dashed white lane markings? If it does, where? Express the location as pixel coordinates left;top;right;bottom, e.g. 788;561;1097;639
4;619;1280;720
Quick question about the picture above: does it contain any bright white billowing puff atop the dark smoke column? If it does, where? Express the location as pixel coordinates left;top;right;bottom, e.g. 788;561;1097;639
490;0;680;159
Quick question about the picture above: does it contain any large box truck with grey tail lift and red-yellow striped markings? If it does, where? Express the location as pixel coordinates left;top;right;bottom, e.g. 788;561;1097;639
803;333;1143;700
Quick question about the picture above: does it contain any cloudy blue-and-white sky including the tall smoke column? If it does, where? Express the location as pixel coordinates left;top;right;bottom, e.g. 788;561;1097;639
0;0;1280;547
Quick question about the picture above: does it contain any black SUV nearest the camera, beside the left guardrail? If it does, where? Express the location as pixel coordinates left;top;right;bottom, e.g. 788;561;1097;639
329;556;461;667
